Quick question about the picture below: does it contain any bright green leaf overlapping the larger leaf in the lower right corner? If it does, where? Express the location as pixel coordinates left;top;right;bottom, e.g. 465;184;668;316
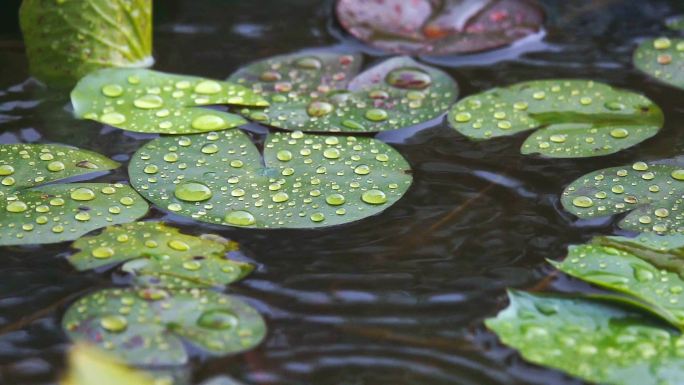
550;235;684;329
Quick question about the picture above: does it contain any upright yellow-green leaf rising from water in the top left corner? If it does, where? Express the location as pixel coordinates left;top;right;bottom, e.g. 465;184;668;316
19;0;154;86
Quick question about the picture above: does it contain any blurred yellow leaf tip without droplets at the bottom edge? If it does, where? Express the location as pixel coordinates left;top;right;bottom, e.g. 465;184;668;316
60;345;160;385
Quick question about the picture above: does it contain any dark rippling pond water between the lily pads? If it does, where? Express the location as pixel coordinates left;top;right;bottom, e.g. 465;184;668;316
0;0;684;385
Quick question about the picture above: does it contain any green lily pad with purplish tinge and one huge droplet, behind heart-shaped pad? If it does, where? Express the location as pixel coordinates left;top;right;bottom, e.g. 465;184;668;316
229;52;458;132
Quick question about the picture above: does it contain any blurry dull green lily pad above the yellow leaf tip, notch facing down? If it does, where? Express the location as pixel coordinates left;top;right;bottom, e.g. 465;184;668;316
62;288;266;366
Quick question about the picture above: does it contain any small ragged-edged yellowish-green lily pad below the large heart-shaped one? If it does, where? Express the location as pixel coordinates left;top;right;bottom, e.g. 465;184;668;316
69;222;251;288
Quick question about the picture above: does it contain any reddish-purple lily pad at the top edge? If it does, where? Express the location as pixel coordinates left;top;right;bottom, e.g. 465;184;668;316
336;0;544;55
